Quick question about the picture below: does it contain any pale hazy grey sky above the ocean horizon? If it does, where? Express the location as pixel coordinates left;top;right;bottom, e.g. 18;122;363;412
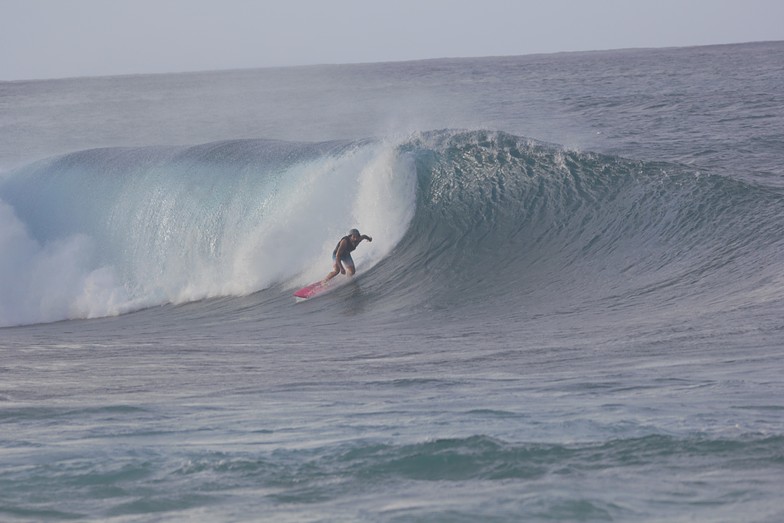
0;0;784;80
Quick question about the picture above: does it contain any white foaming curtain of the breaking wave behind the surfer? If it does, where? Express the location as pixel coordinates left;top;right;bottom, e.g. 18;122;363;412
0;142;415;326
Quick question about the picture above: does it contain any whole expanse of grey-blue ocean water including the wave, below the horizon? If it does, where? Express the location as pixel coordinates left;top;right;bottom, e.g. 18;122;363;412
0;42;784;522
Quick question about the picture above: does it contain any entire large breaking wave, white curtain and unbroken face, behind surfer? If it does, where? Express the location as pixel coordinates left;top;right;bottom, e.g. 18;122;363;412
0;131;784;326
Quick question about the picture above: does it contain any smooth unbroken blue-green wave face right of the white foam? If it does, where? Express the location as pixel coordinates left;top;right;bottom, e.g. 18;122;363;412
382;132;784;324
